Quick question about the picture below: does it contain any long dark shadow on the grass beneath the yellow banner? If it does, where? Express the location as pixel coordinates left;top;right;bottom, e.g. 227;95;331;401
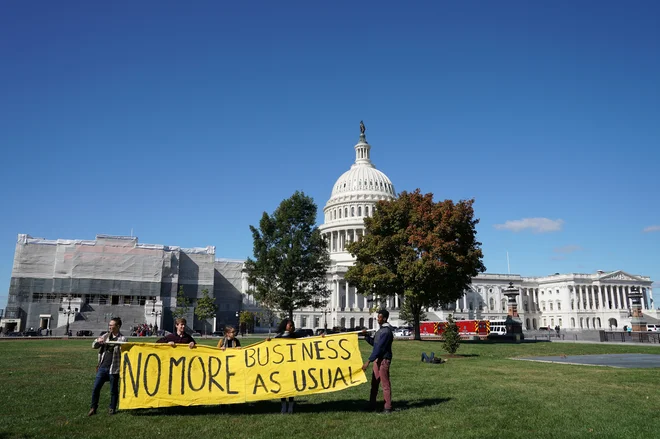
128;397;451;416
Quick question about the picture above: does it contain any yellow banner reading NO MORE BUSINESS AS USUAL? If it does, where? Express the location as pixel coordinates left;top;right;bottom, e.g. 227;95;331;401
119;333;367;409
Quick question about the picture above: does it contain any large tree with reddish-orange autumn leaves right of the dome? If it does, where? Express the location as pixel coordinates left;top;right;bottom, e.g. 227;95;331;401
345;189;486;340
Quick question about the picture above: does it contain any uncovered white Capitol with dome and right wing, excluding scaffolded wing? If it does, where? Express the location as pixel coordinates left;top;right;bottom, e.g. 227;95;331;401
286;125;657;330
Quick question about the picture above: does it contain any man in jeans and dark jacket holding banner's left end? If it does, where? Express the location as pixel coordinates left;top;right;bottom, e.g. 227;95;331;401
87;317;126;416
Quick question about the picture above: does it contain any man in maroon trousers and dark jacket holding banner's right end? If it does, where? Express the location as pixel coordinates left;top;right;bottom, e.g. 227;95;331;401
362;309;394;413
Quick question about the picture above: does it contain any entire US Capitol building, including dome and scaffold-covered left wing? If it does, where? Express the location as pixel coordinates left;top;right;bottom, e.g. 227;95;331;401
0;123;658;335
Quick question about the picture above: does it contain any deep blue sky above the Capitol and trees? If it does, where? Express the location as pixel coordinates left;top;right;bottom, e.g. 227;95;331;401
0;1;660;307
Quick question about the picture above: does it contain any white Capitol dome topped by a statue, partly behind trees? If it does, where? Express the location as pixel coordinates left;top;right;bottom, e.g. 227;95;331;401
320;122;396;264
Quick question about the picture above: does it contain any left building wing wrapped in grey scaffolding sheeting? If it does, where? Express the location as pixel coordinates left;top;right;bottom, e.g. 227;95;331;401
2;234;249;334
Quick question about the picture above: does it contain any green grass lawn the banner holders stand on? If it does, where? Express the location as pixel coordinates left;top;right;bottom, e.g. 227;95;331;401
0;339;660;439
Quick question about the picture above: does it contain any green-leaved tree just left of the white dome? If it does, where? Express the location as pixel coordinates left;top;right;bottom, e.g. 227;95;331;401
245;191;330;318
